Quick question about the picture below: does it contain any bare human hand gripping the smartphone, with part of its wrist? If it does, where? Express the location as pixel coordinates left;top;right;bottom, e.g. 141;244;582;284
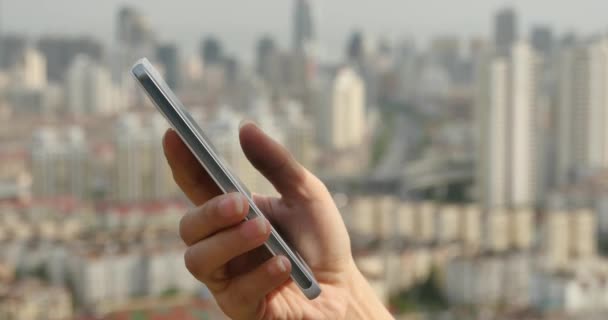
163;123;391;319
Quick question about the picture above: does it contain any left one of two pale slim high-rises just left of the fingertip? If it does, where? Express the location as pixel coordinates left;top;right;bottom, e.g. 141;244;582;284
112;114;144;202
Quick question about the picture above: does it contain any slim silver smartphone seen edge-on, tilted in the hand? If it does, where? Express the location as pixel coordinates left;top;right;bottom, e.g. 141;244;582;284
131;58;321;299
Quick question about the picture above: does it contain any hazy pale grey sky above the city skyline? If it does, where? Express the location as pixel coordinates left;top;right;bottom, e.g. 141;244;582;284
0;0;608;62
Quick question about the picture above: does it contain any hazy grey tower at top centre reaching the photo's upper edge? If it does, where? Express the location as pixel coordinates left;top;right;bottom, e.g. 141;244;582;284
293;0;315;52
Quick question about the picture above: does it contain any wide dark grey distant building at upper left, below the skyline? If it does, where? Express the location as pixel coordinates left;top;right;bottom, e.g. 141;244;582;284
36;36;104;82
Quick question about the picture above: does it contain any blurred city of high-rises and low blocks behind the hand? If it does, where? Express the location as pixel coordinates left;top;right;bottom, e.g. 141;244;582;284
0;0;608;320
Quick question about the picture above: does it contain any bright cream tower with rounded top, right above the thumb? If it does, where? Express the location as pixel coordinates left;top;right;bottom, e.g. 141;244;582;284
317;67;366;150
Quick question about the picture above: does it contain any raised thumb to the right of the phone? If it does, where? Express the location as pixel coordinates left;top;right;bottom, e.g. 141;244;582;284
239;121;323;200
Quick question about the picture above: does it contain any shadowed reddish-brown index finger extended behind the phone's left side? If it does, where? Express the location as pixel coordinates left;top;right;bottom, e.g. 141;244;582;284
163;129;222;206
